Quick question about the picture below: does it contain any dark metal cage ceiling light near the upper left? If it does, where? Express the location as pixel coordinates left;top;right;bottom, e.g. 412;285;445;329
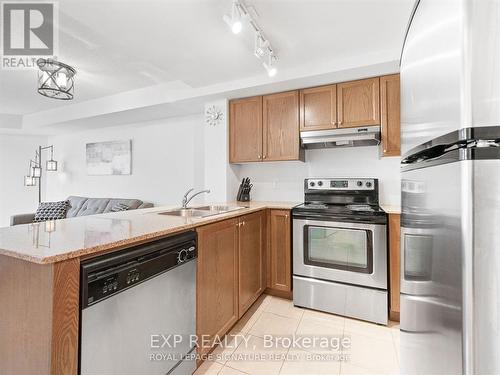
36;58;76;100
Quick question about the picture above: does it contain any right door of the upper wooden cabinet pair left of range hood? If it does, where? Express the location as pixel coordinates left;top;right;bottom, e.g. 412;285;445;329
262;91;300;161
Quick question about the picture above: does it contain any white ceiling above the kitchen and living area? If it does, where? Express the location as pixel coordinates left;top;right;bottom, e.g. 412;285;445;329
0;0;414;123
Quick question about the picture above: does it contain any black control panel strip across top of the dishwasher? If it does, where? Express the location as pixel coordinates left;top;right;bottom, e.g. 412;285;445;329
81;232;197;309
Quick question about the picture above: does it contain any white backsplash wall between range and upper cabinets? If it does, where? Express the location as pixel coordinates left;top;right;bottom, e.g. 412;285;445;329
233;147;401;205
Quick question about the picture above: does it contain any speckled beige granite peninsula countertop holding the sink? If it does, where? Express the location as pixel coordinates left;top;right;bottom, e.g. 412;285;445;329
0;202;299;264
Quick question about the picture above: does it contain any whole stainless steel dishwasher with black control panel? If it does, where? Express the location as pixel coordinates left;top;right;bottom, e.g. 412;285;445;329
80;231;197;375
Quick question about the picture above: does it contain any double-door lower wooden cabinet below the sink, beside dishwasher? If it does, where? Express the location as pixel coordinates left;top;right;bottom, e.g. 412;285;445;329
196;211;266;355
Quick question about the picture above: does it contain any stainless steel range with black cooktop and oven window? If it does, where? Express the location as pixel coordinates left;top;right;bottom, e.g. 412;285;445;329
292;178;388;324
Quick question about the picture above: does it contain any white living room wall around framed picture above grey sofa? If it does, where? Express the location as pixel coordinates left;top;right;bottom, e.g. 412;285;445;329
46;115;205;206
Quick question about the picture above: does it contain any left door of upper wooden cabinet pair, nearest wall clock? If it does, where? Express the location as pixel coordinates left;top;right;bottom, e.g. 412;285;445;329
229;96;262;163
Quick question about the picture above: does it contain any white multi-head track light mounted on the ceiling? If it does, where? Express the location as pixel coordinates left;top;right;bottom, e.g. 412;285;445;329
222;0;278;77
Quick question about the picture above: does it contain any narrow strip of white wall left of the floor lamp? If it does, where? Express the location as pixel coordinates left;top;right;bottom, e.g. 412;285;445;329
0;135;47;227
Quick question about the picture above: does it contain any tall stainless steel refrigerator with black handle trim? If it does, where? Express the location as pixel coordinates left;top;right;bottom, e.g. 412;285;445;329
400;0;500;375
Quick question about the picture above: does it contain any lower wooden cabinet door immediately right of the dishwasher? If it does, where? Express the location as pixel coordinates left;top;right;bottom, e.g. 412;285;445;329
196;219;238;354
